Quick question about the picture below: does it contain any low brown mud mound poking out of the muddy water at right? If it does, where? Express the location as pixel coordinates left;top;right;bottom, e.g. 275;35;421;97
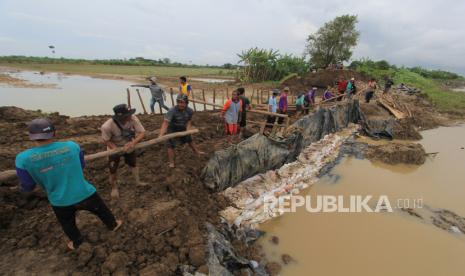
365;142;426;165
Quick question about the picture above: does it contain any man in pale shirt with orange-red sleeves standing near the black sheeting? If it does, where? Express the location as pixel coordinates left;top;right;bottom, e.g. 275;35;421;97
221;90;242;144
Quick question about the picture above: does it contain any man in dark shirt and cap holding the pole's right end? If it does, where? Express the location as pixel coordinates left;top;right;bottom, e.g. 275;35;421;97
159;94;203;168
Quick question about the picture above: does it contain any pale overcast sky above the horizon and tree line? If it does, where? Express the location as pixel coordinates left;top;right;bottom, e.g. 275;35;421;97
0;0;465;74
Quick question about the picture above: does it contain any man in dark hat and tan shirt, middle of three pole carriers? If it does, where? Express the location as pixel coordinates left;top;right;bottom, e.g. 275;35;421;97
101;104;147;198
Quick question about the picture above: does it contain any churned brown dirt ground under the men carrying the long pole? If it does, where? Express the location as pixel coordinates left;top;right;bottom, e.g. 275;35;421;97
0;107;260;275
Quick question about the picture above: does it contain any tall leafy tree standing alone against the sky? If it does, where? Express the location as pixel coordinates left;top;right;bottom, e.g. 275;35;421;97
305;15;360;68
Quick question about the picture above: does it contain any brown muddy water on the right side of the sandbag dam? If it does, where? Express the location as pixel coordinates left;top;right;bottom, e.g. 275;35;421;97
261;126;465;275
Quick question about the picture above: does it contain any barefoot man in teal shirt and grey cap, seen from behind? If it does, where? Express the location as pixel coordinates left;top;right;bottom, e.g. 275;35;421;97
16;118;122;249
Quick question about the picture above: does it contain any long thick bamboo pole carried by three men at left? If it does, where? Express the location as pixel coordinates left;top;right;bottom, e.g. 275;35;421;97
0;129;199;181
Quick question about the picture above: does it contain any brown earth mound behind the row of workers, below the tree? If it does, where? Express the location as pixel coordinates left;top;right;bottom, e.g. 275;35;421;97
283;70;368;92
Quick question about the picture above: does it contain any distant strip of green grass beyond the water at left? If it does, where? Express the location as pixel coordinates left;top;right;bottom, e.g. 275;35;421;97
0;63;235;77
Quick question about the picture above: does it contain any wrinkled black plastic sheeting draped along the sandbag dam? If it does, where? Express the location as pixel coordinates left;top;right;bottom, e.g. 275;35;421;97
201;100;363;191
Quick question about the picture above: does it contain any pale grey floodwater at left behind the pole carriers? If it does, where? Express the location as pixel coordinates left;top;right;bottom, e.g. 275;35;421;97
0;71;218;117
